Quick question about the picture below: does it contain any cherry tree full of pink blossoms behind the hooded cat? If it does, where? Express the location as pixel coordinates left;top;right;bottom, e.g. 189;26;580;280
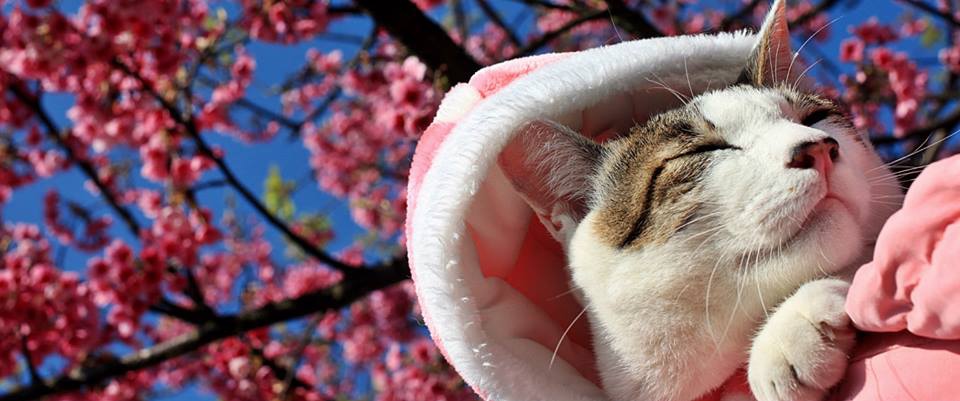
0;0;960;401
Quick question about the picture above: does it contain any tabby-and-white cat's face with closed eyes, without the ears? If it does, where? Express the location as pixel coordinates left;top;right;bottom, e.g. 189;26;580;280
578;85;884;273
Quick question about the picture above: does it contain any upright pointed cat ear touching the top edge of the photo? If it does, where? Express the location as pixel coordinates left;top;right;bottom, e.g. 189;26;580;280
740;0;793;86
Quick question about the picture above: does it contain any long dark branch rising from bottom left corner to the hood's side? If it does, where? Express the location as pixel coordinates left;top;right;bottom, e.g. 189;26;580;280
0;261;407;401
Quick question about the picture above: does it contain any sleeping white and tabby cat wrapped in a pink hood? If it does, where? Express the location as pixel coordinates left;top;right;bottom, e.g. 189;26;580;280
501;0;901;401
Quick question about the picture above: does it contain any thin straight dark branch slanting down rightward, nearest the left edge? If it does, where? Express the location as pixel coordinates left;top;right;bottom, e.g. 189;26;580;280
8;83;140;234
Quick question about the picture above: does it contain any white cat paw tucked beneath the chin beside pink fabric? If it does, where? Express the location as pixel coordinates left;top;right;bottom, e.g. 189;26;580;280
747;279;854;401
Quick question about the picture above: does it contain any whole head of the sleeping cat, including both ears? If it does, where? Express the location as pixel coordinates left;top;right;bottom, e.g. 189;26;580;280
501;1;899;298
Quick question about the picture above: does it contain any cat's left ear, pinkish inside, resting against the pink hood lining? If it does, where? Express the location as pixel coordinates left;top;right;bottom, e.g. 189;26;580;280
498;120;601;245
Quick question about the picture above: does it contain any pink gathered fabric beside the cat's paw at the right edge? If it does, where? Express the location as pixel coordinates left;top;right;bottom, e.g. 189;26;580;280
835;156;960;401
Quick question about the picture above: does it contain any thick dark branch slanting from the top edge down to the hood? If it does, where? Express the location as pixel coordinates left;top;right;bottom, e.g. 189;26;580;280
355;0;481;85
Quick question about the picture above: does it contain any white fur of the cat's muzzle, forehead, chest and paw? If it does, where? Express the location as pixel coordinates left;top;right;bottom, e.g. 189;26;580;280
569;87;898;401
